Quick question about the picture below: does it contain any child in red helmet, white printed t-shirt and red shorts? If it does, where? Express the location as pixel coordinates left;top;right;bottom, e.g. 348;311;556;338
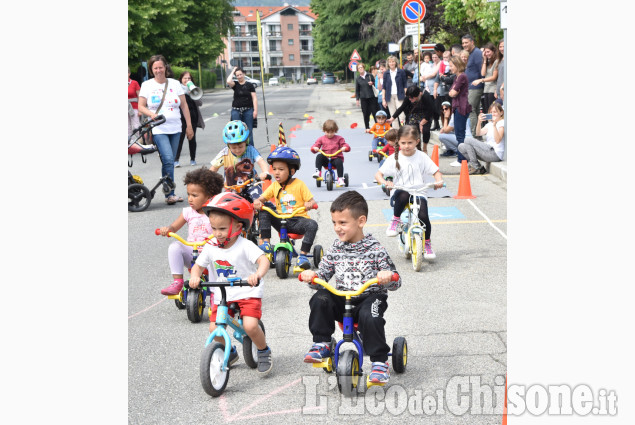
190;192;273;375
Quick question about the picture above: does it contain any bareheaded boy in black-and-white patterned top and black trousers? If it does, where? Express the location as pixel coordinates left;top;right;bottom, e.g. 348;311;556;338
301;190;401;383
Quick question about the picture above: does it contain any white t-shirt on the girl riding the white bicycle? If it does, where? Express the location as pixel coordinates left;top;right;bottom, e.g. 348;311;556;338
379;150;439;199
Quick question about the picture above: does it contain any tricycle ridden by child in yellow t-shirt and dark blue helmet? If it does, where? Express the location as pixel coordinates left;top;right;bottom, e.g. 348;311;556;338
262;204;324;279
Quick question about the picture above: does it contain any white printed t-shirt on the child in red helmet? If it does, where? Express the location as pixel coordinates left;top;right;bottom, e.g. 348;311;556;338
196;236;265;304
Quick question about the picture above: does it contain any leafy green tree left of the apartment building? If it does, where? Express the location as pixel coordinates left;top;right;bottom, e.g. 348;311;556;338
128;0;233;67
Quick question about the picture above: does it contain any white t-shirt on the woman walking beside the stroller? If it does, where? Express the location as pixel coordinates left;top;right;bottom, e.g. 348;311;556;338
139;78;185;134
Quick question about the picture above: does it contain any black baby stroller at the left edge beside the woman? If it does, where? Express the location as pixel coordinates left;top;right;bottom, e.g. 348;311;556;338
128;115;176;212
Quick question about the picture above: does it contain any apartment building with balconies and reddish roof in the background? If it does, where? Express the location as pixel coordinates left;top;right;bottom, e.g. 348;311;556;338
217;6;317;80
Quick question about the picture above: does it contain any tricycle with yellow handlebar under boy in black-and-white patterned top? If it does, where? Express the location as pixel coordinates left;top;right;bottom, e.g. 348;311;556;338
298;273;408;396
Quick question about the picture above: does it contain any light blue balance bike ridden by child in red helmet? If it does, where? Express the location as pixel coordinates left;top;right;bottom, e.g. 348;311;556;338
194;277;265;397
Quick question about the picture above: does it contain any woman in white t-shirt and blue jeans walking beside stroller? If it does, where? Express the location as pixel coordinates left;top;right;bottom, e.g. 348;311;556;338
139;55;194;205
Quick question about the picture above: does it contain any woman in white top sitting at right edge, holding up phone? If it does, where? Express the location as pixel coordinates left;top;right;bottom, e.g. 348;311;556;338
459;102;505;174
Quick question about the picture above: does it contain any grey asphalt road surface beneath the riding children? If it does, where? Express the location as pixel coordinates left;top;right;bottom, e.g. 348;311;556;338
128;84;507;424
